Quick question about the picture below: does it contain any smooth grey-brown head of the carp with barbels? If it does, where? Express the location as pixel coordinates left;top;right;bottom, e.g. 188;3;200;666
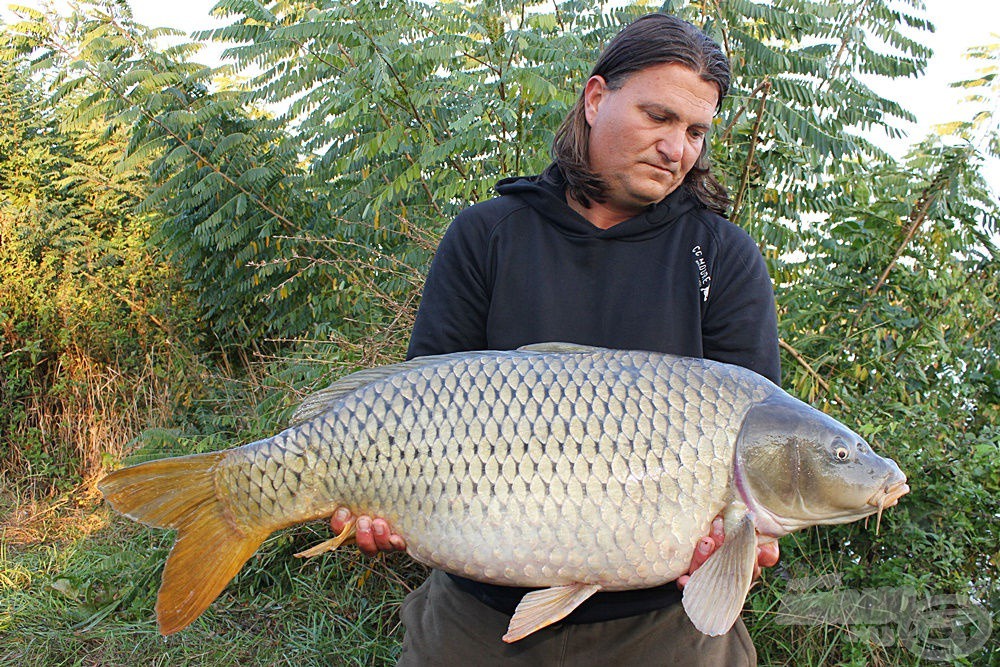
735;392;910;536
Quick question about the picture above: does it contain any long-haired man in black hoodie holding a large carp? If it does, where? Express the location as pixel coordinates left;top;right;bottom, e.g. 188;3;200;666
332;14;780;666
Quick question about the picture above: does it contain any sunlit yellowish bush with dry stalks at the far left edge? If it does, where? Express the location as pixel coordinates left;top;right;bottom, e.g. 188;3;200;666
0;15;205;494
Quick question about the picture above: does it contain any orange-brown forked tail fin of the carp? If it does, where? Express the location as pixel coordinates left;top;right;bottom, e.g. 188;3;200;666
98;452;272;636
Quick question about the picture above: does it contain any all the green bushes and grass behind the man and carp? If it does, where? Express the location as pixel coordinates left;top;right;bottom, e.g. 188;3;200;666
0;0;1000;665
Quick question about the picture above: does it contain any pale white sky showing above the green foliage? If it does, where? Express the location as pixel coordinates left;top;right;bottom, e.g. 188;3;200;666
7;0;1000;171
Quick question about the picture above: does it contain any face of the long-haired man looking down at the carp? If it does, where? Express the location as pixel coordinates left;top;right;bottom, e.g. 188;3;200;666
584;63;719;219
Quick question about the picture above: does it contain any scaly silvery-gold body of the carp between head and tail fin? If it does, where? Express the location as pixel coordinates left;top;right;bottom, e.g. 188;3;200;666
219;351;760;590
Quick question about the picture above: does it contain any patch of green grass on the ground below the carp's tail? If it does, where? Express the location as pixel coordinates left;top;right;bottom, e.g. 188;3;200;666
0;489;423;667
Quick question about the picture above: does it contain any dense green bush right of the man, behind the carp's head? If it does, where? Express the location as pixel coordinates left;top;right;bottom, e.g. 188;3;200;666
761;39;1000;664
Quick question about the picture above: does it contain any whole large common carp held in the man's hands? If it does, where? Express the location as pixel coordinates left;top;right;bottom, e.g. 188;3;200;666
99;343;909;641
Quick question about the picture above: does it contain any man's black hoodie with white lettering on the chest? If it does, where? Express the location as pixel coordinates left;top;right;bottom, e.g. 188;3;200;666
407;167;781;623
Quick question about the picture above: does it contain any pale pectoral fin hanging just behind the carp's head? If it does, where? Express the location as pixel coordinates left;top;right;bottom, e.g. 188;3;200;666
683;515;757;637
